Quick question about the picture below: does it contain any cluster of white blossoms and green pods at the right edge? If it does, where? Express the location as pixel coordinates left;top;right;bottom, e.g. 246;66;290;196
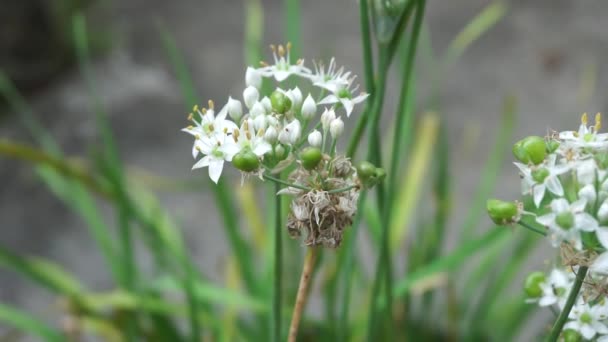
488;113;608;341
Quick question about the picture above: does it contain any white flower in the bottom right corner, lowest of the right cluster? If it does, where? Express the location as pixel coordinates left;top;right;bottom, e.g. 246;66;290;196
564;301;608;340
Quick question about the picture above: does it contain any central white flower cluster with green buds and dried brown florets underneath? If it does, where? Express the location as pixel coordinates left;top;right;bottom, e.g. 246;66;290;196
183;44;383;247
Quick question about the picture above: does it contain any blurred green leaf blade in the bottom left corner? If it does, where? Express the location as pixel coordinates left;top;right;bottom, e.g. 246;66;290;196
0;303;67;342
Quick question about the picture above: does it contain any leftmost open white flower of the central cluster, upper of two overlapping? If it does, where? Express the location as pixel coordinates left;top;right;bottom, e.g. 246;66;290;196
182;101;238;158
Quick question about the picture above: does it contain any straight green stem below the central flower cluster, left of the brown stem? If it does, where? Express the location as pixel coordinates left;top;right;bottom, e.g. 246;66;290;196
271;183;283;342
